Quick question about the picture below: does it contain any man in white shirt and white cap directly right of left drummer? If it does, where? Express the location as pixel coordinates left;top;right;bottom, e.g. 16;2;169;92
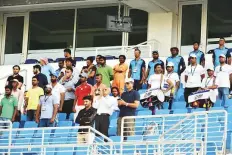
164;62;180;110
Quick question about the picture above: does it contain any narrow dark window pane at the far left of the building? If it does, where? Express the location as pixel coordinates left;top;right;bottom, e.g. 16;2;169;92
5;17;24;54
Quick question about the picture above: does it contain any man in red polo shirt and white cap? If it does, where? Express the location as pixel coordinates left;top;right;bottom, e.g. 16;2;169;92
73;72;92;120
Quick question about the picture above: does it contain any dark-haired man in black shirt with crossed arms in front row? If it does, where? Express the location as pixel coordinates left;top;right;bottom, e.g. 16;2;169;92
75;96;97;143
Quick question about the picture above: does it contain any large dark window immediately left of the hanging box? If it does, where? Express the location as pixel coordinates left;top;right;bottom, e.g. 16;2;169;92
76;6;122;48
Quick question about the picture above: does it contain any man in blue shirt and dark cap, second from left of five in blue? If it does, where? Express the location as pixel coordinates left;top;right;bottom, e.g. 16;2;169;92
146;51;165;80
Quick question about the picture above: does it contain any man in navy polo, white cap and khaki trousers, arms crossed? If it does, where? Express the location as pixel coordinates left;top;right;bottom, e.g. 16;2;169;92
117;78;140;139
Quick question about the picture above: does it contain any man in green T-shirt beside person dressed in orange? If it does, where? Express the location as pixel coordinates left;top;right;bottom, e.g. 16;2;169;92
97;56;114;88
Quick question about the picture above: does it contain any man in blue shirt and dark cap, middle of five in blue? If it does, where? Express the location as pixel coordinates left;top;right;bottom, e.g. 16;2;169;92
166;47;186;76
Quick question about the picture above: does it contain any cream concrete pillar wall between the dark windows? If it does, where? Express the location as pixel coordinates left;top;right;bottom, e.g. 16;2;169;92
147;12;177;56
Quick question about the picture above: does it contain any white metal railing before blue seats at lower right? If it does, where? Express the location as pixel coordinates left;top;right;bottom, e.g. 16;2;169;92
121;110;227;154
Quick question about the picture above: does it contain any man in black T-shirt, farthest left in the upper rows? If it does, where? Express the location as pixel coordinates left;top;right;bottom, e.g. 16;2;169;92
6;65;23;89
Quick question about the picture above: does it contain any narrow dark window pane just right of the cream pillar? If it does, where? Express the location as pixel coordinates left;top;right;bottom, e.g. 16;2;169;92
181;4;202;46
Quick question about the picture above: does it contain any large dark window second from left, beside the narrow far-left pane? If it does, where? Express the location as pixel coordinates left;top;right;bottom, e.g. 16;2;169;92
29;10;75;50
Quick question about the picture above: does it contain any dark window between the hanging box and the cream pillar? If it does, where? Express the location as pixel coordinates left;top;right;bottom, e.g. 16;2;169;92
128;9;148;45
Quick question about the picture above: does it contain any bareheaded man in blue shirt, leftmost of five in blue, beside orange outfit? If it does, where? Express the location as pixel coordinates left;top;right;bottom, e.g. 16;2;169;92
128;48;146;91
